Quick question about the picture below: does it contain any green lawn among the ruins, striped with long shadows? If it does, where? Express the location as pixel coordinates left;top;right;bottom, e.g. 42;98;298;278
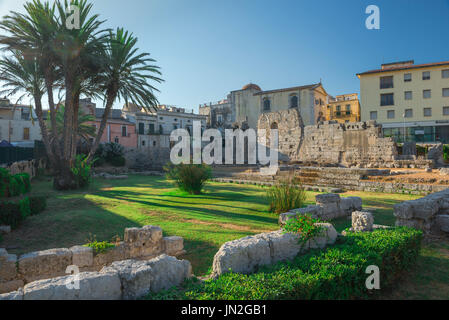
0;175;449;298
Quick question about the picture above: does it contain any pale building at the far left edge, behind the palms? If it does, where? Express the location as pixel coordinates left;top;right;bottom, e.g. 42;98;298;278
0;98;42;146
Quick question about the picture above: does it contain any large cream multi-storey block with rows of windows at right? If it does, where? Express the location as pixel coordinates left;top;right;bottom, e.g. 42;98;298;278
357;61;449;143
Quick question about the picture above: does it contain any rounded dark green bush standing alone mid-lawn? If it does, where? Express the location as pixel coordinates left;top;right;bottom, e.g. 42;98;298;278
164;164;212;194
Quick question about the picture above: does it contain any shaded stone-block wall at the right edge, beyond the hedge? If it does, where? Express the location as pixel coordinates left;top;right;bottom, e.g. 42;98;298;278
394;189;449;234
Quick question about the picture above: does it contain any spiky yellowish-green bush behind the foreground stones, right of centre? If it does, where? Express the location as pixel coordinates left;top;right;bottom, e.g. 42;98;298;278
267;180;306;214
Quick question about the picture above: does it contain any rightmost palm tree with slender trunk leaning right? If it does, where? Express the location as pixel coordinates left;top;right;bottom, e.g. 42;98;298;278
88;28;163;160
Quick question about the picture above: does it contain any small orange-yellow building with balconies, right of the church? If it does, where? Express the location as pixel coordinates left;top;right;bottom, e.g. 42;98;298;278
326;93;360;123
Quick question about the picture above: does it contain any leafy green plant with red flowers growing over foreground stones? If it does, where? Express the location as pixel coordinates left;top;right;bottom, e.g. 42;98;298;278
282;214;323;245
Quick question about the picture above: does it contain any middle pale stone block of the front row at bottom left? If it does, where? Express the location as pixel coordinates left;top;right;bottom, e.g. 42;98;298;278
101;260;153;300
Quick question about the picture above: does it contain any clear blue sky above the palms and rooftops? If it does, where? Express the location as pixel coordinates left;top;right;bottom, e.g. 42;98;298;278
0;0;449;110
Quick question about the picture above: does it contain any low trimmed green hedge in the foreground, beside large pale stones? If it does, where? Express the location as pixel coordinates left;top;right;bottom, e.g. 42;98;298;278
147;227;422;300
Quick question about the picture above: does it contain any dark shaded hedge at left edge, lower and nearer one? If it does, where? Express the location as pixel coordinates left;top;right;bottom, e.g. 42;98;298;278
0;197;47;229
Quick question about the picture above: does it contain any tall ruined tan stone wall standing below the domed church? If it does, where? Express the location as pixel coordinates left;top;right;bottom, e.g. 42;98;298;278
258;109;398;167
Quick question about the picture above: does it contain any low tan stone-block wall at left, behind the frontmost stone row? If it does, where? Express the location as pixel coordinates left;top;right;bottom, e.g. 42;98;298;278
0;226;184;293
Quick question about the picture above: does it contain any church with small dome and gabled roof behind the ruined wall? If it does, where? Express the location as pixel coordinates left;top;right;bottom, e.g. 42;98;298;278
200;83;329;129
